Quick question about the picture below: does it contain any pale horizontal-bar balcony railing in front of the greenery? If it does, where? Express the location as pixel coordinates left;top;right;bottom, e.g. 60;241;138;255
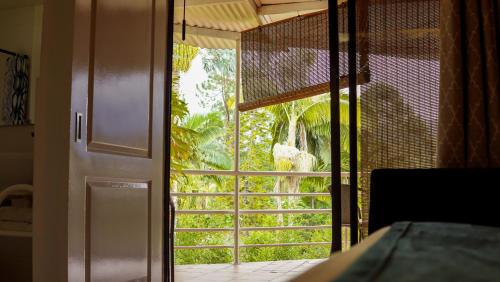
171;170;349;264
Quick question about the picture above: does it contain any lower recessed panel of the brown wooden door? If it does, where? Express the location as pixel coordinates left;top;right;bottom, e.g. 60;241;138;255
86;180;150;282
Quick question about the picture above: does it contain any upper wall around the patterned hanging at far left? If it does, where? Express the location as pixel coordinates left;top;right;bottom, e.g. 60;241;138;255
0;5;43;123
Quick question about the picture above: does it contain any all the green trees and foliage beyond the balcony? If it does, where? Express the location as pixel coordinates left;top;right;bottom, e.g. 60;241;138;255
171;45;356;264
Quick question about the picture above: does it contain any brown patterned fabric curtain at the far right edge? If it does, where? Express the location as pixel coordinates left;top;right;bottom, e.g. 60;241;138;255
438;0;500;167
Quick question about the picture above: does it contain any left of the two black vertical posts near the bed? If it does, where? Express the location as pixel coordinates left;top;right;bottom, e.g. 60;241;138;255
328;0;342;253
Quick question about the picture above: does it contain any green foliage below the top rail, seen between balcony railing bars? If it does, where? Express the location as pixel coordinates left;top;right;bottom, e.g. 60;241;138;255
175;176;331;264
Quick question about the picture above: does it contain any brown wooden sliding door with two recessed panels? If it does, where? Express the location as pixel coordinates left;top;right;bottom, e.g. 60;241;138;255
68;0;167;282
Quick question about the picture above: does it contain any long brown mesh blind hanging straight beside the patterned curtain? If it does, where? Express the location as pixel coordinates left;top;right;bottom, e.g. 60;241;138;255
358;0;439;238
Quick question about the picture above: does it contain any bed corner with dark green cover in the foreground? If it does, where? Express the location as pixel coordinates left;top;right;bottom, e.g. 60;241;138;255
293;222;500;282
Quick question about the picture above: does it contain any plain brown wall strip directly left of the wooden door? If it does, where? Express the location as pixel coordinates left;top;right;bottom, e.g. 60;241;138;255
33;0;73;282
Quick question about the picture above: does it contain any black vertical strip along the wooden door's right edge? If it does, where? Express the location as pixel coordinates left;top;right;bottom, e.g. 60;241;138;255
162;0;174;282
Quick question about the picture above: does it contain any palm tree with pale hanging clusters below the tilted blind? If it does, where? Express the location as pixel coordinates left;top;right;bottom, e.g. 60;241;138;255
269;91;359;220
